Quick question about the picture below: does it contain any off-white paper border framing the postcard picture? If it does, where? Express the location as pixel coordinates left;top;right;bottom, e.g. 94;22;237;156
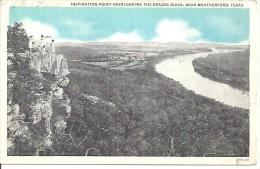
0;0;259;165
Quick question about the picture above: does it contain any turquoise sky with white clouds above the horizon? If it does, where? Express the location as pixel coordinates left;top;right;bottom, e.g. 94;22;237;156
9;7;249;44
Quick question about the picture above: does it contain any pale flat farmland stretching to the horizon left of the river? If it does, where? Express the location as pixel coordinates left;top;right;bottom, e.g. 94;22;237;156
56;43;211;70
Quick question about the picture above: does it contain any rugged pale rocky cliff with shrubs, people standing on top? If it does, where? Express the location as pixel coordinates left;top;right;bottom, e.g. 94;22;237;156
7;52;71;155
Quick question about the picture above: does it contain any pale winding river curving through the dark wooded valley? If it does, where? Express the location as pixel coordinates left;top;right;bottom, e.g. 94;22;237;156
155;49;249;109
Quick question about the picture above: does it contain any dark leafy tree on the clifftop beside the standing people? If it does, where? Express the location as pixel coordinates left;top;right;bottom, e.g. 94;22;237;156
7;22;29;53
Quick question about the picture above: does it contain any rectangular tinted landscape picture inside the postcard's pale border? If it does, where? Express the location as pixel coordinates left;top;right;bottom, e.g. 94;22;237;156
1;0;256;163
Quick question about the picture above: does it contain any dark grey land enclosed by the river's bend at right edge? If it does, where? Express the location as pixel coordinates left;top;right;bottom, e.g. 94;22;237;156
192;50;249;91
